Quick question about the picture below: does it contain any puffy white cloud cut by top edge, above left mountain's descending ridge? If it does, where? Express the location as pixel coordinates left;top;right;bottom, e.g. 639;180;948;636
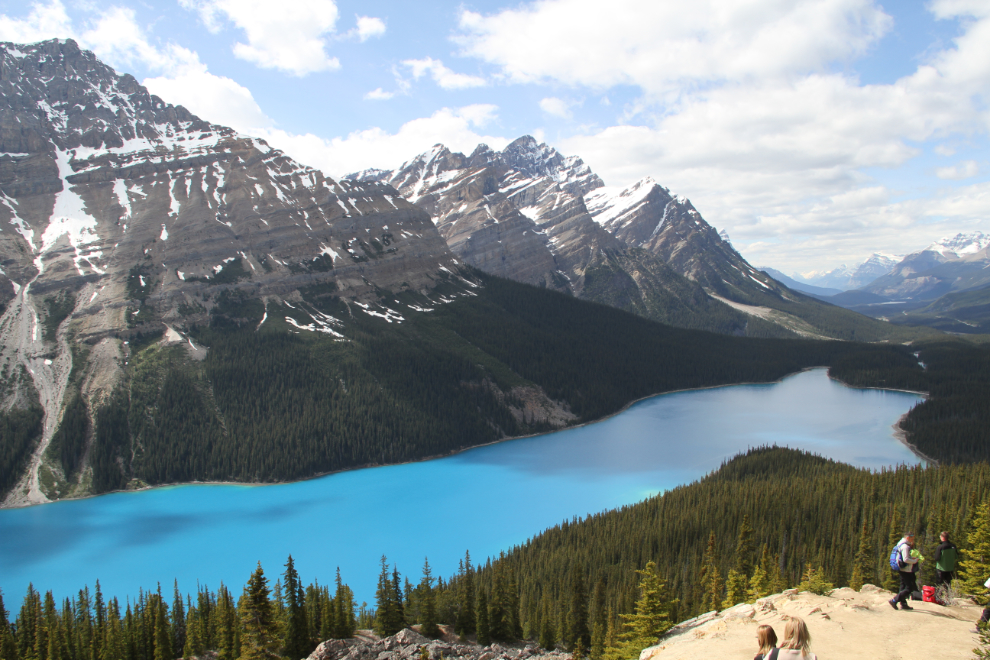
180;0;340;76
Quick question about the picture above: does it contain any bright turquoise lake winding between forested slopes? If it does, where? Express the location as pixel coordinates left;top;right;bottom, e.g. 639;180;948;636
0;369;921;612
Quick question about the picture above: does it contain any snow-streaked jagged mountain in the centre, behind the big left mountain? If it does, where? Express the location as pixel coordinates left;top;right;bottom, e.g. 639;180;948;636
345;136;792;332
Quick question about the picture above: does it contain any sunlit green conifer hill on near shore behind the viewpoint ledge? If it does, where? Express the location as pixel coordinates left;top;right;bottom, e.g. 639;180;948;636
438;448;990;658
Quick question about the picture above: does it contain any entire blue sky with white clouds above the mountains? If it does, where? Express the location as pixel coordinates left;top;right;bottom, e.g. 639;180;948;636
0;0;990;273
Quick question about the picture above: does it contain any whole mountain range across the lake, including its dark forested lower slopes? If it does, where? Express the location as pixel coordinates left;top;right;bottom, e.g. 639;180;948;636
0;40;986;506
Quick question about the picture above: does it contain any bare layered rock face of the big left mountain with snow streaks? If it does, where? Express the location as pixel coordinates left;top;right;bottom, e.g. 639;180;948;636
0;40;466;501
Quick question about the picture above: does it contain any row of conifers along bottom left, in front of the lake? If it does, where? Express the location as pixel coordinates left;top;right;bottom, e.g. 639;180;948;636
0;556;359;660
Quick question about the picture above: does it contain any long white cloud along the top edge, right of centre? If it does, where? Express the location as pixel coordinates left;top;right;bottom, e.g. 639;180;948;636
456;0;892;94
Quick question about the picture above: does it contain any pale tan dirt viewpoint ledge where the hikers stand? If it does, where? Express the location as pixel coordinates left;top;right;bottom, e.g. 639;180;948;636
639;584;982;660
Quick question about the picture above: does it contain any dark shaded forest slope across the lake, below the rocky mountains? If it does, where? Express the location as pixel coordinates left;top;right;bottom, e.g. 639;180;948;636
75;273;925;492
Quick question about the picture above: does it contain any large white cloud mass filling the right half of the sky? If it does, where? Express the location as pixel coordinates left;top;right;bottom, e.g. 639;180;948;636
457;0;990;270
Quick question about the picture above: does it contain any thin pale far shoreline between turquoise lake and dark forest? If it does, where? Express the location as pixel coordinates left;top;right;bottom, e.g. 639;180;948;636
0;365;938;510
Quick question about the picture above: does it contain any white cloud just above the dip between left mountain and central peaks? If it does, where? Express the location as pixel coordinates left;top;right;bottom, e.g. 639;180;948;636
254;104;510;177
